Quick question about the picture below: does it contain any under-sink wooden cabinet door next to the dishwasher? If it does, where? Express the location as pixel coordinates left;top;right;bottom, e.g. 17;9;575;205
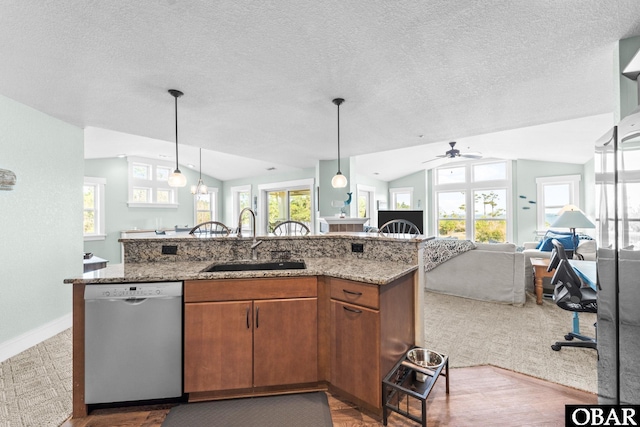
184;301;253;393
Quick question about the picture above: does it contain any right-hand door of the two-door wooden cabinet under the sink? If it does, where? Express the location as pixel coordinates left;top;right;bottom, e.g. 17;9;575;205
254;298;318;387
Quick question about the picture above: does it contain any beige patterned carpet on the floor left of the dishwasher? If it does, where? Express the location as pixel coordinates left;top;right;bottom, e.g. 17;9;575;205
0;329;72;427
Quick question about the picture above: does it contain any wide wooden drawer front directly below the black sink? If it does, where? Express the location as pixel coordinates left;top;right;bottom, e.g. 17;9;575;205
184;276;318;302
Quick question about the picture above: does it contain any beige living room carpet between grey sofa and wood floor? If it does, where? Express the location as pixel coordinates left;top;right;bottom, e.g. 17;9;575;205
425;292;597;393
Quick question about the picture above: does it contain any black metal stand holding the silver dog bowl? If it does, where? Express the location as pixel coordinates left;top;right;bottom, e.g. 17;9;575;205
382;352;449;427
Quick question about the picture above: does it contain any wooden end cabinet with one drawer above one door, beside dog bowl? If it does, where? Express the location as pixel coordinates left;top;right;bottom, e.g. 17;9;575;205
326;274;415;412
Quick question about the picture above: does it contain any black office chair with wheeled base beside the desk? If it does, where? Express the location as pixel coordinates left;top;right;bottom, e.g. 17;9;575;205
550;244;598;351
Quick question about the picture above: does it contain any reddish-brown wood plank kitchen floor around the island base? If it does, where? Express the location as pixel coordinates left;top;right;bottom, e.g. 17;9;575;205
61;366;598;427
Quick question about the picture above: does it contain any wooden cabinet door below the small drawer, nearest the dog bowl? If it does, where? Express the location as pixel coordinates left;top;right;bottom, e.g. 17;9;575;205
331;300;382;408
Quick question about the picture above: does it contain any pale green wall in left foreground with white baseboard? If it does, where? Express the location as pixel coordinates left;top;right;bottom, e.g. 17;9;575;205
0;96;84;344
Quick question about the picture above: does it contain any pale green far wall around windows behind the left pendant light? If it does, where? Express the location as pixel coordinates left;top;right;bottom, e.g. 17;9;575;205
84;158;222;264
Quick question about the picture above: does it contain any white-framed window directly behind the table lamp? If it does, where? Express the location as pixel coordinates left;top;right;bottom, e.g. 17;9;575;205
536;175;580;232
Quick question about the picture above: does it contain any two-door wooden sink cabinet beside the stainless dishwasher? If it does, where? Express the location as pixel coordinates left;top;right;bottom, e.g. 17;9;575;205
184;277;318;393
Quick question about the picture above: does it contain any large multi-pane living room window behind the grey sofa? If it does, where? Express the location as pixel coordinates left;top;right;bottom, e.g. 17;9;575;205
434;161;511;242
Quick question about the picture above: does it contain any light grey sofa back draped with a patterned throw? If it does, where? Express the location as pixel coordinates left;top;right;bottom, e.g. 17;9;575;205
425;242;526;305
